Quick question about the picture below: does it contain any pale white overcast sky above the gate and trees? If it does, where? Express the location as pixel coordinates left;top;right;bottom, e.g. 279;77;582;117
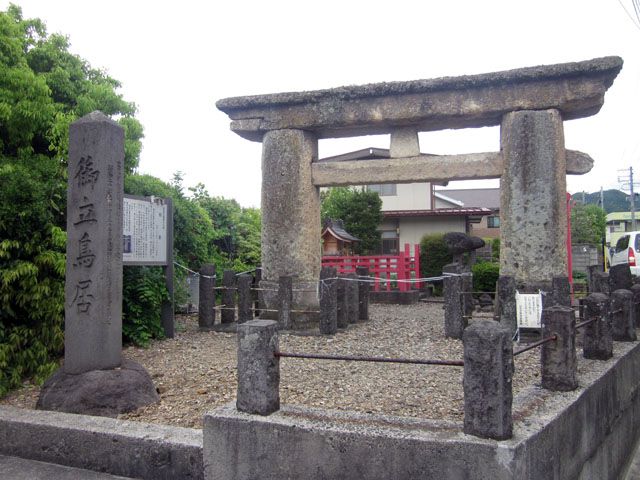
5;0;640;206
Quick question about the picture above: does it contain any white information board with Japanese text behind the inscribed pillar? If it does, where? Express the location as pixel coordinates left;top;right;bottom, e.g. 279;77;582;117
122;197;167;265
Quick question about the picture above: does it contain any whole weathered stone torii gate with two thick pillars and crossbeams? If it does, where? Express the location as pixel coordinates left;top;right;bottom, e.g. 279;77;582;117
216;57;622;323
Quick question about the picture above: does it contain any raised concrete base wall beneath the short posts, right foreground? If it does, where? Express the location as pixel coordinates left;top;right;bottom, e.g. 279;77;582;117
204;343;640;480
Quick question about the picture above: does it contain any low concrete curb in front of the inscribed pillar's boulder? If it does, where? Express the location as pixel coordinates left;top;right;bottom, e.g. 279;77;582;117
0;406;204;480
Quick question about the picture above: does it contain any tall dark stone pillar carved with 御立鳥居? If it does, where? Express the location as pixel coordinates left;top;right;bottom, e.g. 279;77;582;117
64;112;124;374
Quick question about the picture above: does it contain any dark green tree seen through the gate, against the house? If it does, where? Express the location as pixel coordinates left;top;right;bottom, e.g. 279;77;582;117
321;187;383;255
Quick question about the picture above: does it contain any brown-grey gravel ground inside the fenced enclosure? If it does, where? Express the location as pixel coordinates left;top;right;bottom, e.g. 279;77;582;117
0;303;540;428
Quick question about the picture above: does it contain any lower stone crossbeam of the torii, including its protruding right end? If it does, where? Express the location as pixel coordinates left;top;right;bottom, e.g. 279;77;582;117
311;150;593;187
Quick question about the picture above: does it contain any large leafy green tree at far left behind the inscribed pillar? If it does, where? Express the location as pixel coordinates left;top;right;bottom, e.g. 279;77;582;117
0;5;143;395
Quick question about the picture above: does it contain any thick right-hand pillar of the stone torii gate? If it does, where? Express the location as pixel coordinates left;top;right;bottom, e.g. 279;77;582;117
500;110;567;284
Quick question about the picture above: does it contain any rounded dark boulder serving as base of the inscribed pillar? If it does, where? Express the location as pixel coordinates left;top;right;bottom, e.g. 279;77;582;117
36;359;160;417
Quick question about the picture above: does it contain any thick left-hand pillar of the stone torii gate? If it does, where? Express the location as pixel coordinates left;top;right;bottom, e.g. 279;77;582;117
261;130;322;322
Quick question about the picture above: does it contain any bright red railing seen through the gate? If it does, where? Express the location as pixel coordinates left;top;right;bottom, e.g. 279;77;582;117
322;243;420;292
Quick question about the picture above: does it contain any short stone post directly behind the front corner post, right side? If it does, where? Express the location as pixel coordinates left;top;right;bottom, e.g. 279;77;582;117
540;305;578;392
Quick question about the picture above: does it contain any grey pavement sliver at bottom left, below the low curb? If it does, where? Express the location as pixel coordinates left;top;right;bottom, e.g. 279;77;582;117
0;455;136;480
